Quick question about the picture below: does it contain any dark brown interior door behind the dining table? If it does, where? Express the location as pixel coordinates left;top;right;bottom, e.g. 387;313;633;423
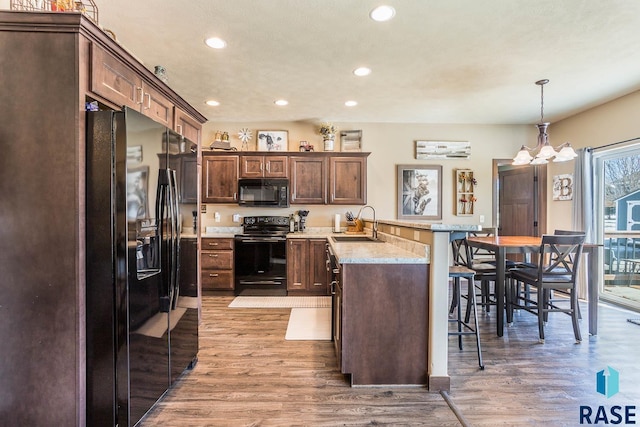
498;166;547;236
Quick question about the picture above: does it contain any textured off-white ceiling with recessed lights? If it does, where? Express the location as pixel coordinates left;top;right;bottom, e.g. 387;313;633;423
95;0;640;124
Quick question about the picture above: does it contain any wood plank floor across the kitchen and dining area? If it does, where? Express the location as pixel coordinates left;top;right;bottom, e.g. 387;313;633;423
140;297;640;427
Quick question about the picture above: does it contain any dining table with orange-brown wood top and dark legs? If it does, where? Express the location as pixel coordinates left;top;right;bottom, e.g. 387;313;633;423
467;236;602;337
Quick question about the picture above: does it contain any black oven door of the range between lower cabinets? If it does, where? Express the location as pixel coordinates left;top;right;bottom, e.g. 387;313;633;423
234;235;287;295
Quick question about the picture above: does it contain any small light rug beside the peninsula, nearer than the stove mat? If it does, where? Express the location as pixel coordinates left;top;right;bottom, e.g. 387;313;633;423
284;307;331;341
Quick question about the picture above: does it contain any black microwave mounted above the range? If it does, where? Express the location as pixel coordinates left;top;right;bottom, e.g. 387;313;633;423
238;178;289;208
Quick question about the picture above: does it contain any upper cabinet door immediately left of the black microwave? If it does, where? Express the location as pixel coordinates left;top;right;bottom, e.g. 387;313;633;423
202;156;239;203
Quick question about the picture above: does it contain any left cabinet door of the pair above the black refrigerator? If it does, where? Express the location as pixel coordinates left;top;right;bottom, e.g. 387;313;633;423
91;44;142;110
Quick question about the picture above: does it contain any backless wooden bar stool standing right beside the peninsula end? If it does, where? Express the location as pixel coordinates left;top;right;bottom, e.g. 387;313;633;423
449;265;484;369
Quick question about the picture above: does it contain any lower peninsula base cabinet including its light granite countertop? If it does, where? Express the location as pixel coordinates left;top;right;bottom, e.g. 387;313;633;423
327;236;429;385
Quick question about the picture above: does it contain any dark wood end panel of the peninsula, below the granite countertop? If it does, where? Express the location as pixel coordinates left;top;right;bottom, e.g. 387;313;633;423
334;264;429;385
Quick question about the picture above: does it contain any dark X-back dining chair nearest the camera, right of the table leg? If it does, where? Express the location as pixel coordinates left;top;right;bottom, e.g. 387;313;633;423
507;234;585;343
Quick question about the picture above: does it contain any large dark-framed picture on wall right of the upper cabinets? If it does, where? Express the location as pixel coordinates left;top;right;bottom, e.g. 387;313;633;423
397;165;442;220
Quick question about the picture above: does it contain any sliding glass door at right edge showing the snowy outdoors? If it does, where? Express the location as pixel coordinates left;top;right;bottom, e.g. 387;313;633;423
593;143;640;311
